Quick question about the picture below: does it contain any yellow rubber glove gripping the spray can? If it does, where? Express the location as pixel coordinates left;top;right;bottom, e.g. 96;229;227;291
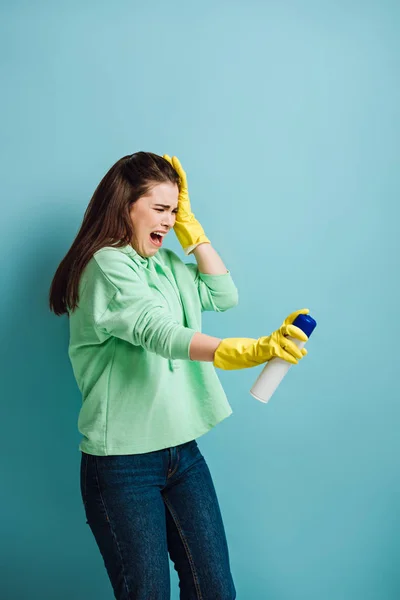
213;308;310;371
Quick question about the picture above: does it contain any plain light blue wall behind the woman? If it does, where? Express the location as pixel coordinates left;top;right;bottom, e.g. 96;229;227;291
0;0;400;600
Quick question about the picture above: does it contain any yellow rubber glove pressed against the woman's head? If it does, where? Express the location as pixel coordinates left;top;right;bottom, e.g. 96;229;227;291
163;154;211;255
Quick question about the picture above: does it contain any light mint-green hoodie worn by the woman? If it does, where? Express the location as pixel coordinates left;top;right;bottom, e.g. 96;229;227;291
68;245;238;456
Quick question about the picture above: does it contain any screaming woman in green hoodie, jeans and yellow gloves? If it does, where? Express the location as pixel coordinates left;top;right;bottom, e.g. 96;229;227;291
50;152;308;600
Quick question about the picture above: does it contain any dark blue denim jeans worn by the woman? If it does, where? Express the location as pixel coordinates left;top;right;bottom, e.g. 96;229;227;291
81;440;236;600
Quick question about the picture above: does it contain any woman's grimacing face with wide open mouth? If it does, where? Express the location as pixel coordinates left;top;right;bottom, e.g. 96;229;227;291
130;182;179;257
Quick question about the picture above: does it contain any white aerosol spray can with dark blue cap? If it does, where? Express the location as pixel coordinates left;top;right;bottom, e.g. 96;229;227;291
250;315;317;403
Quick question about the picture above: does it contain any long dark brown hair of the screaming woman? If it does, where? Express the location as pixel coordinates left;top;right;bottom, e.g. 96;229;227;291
49;152;179;315
